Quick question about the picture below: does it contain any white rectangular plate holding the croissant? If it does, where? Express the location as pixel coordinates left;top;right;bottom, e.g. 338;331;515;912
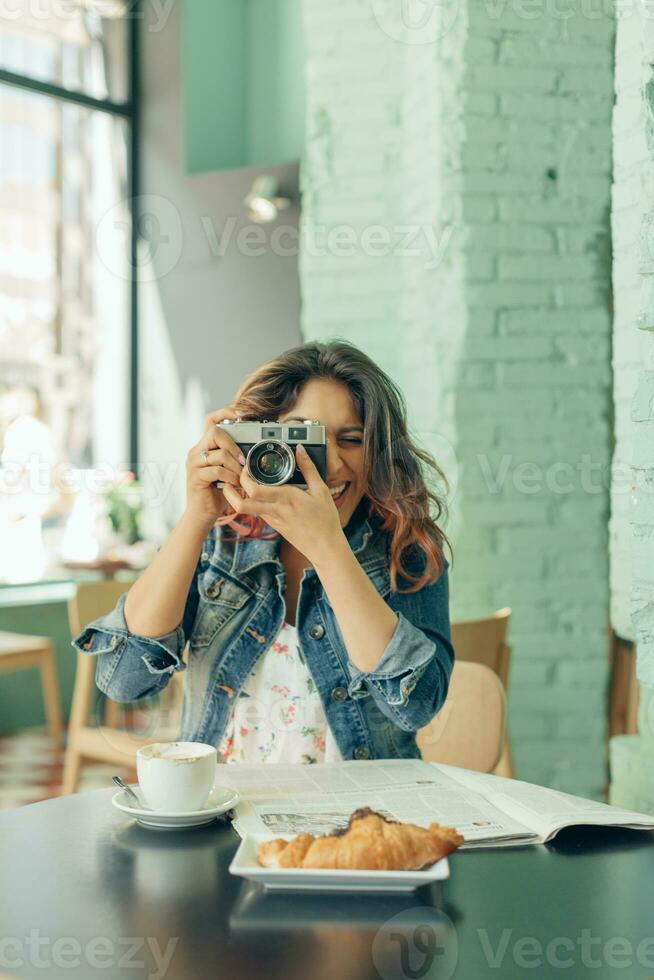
229;836;450;892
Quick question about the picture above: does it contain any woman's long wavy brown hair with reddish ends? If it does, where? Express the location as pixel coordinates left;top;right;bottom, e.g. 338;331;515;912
219;340;451;592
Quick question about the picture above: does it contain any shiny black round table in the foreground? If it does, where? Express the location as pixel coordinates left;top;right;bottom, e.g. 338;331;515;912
0;789;654;980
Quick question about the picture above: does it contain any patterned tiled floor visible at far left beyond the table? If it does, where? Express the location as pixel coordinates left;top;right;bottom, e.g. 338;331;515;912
0;728;136;810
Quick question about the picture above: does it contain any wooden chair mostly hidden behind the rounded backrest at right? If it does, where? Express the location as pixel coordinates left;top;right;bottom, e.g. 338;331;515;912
452;607;515;778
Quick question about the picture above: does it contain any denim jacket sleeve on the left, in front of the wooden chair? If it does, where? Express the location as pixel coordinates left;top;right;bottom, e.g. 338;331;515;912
72;571;198;702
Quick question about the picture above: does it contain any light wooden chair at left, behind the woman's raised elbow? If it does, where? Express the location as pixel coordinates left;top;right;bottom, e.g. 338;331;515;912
62;581;183;795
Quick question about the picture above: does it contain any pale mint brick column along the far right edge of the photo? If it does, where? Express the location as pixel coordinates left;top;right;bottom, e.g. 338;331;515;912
610;5;654;813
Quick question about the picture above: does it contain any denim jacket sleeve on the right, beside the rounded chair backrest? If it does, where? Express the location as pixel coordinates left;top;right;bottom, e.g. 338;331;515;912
348;559;454;731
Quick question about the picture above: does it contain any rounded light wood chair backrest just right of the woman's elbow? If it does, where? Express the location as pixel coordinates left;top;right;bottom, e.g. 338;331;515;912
417;662;506;772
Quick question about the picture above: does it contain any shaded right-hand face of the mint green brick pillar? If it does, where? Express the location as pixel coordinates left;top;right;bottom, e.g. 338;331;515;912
455;2;614;796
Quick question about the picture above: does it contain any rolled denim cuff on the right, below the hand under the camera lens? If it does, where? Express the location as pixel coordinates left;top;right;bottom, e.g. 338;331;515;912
348;613;436;705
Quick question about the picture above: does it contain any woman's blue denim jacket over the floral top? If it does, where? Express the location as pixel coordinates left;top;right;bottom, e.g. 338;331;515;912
73;515;454;759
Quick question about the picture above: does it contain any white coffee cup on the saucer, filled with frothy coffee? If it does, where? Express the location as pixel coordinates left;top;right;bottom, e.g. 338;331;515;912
136;742;218;813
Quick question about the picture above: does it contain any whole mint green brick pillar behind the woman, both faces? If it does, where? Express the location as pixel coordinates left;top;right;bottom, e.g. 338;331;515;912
301;0;613;795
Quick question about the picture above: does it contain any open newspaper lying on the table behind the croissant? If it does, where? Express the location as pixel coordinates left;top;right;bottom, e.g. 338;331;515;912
217;759;654;848
